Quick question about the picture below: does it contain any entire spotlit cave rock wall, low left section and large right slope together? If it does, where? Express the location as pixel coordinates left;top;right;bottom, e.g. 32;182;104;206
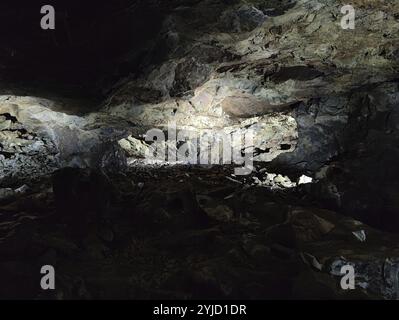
0;0;399;227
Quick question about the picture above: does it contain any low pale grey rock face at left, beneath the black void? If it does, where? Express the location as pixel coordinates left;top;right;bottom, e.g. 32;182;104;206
0;96;130;184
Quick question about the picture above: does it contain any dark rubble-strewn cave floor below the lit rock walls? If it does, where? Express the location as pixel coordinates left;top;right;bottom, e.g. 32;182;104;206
0;166;399;299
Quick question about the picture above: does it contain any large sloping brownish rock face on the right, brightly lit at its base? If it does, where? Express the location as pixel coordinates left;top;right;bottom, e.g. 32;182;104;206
101;0;399;228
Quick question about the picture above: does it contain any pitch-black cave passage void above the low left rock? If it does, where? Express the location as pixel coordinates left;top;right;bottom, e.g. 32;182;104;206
0;0;167;98
